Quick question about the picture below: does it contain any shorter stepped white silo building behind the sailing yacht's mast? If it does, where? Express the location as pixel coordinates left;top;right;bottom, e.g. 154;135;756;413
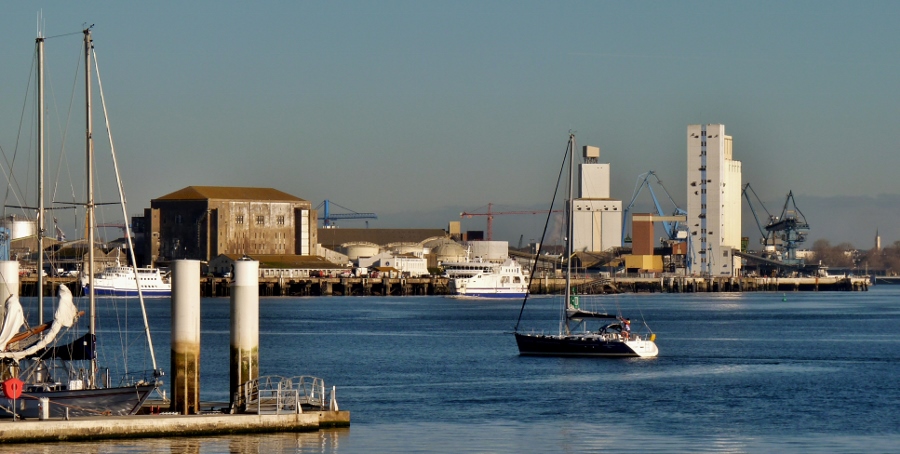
572;146;622;252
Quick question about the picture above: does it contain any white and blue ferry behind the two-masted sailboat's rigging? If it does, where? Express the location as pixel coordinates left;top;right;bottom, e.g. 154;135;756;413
81;265;172;298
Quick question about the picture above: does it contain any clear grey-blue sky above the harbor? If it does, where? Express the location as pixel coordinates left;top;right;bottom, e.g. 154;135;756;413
0;1;900;249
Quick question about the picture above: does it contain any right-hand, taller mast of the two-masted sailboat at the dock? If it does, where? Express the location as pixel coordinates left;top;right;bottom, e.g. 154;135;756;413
84;28;97;386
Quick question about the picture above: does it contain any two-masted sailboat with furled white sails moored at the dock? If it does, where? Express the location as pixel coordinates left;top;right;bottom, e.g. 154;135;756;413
0;28;162;418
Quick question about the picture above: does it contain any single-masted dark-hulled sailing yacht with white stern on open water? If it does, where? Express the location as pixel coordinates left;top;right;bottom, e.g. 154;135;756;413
513;133;659;358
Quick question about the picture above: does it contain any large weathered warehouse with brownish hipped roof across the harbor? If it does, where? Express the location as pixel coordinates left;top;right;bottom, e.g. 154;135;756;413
140;186;317;265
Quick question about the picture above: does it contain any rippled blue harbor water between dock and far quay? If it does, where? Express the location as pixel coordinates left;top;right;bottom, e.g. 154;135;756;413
0;286;900;453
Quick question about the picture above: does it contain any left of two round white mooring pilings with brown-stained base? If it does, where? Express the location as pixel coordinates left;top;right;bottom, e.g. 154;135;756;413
171;260;200;415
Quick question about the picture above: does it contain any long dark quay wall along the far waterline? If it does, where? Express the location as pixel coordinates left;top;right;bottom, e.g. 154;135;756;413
20;275;870;297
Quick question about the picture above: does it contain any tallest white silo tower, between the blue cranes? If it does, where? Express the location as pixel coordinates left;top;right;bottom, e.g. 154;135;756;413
687;124;741;276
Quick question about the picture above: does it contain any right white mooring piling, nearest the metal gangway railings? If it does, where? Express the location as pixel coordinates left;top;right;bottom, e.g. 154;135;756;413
230;259;259;404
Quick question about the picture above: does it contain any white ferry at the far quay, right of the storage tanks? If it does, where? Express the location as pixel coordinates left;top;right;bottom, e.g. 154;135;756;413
442;258;528;298
